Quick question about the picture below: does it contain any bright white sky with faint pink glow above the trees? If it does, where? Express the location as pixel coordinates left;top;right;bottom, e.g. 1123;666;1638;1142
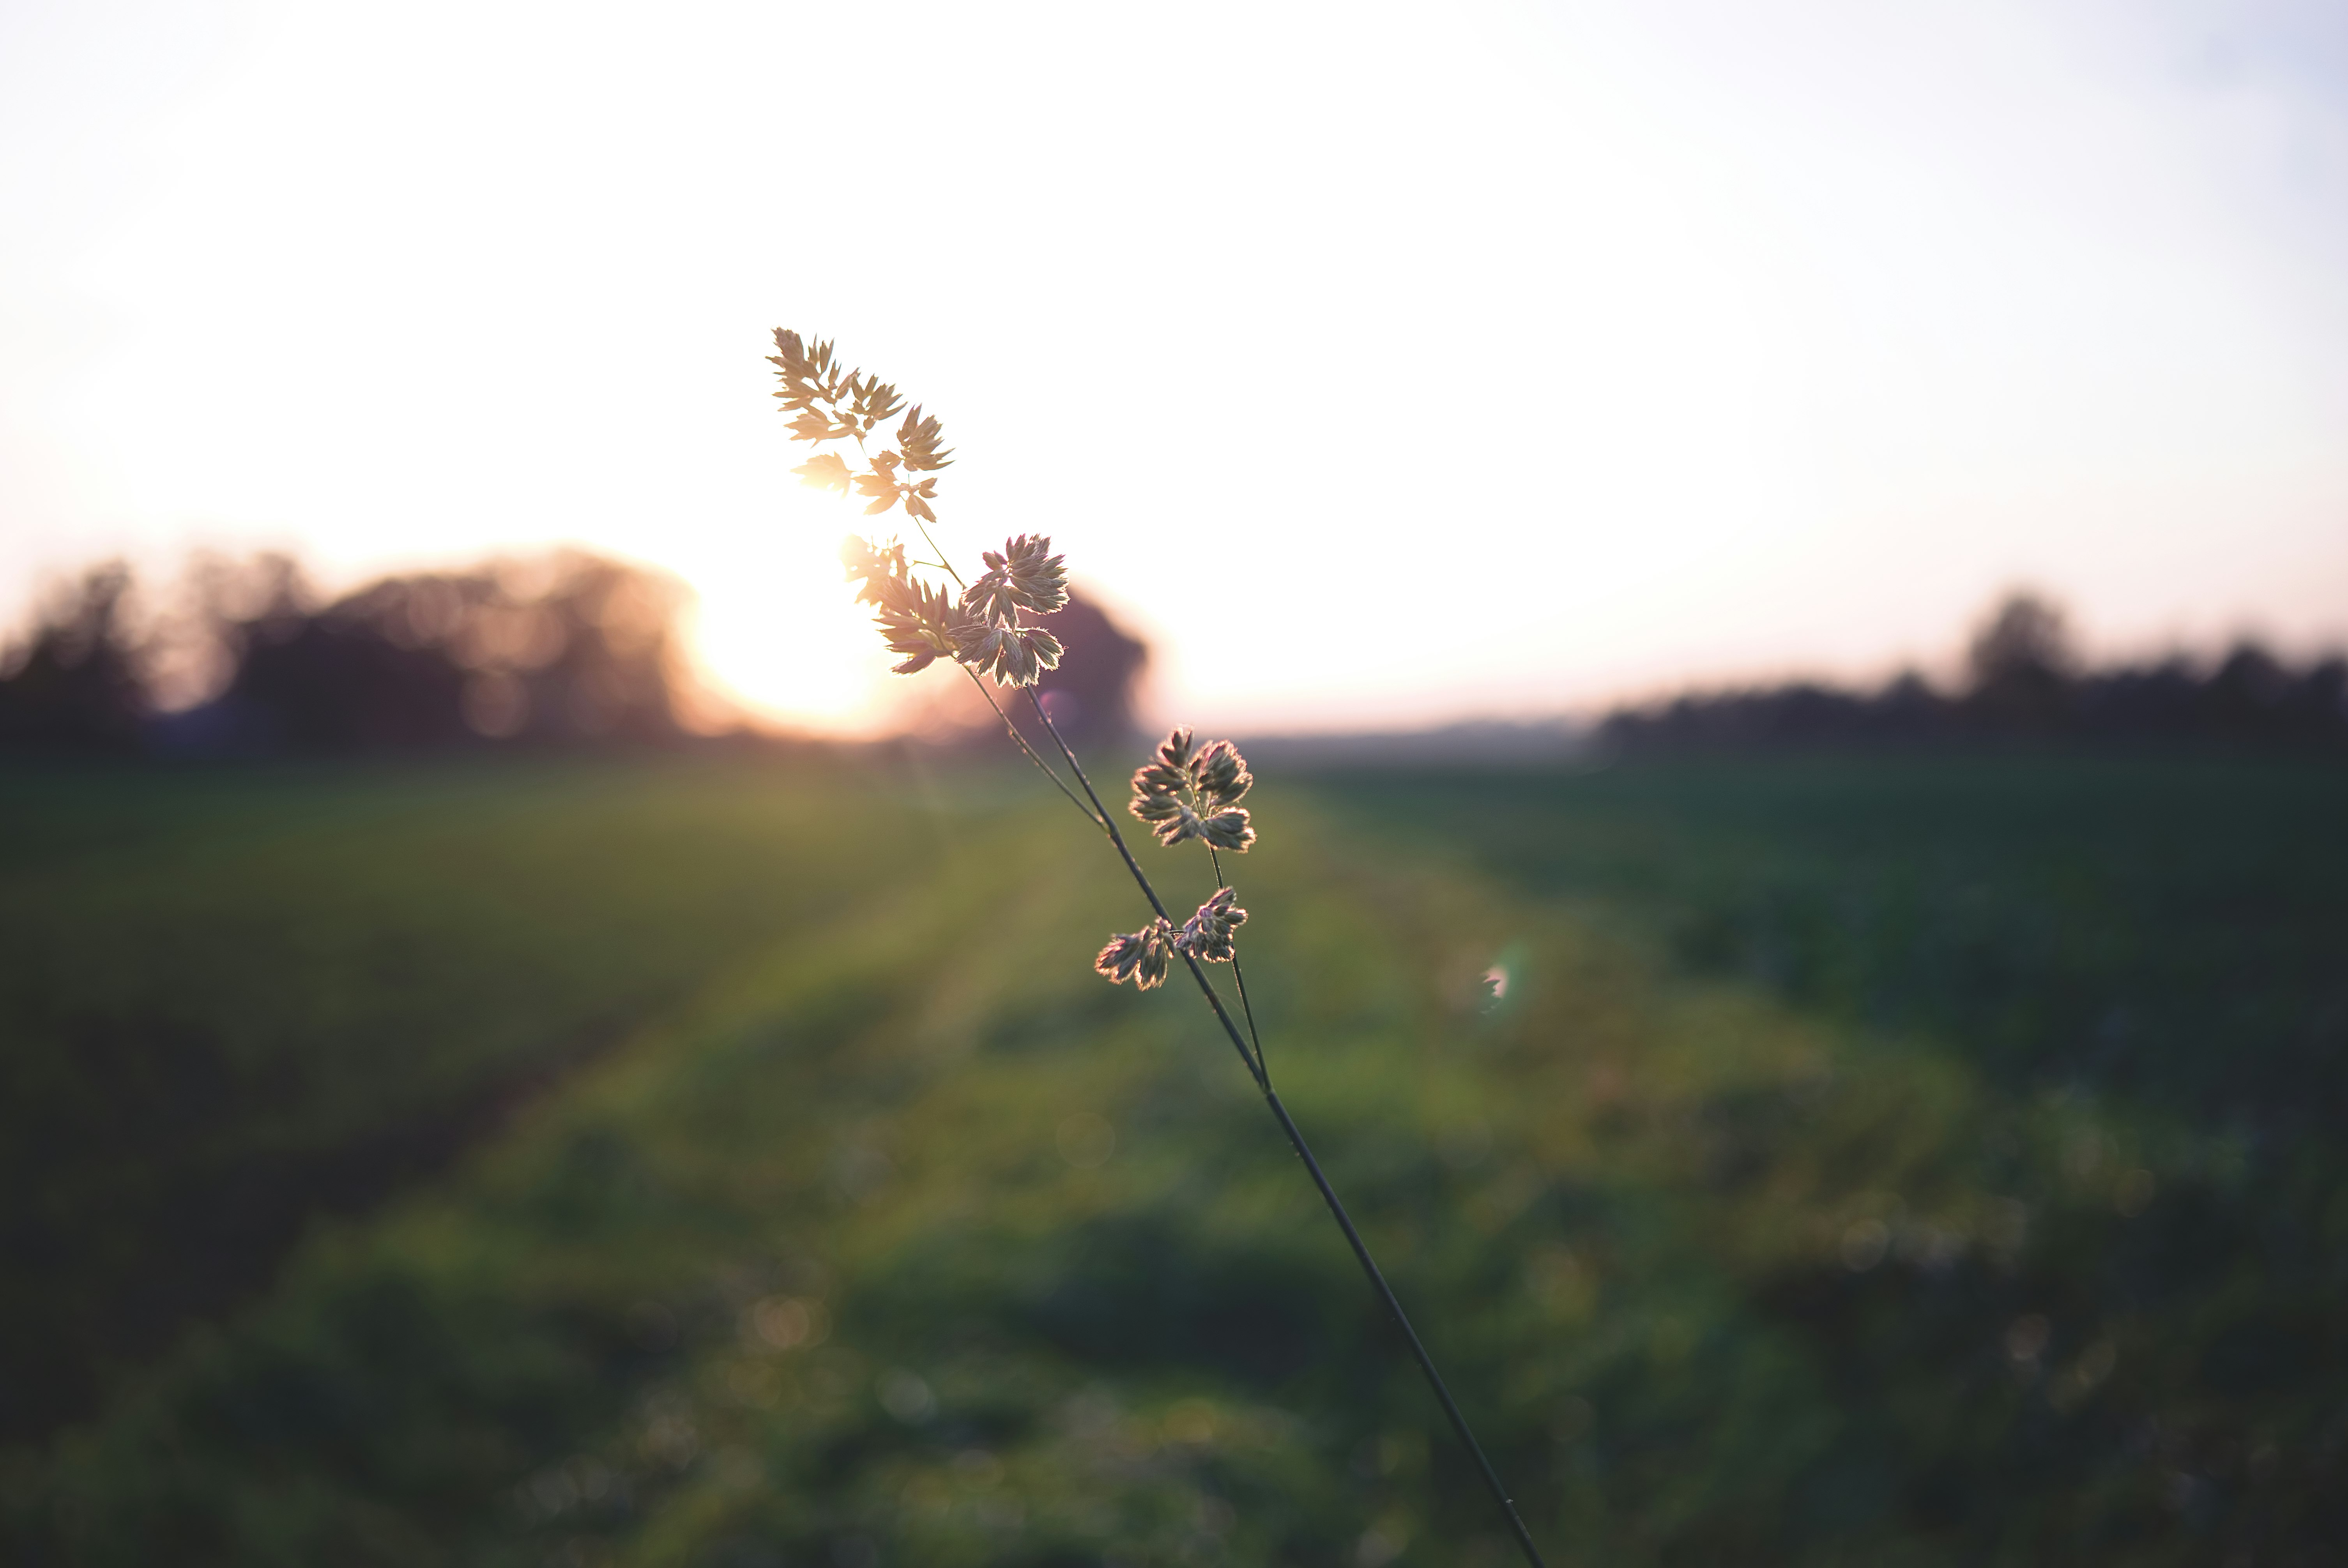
0;0;2348;730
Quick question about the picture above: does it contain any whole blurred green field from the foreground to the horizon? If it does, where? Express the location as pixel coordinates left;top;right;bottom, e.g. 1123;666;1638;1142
0;758;2348;1568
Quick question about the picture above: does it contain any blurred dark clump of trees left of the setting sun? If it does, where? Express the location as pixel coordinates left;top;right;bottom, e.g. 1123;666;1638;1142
0;552;686;756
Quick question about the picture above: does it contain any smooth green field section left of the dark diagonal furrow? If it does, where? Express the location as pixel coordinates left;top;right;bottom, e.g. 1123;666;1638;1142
0;763;934;1439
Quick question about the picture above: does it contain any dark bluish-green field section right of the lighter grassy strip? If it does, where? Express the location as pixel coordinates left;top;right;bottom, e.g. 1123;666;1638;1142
1322;754;2348;1134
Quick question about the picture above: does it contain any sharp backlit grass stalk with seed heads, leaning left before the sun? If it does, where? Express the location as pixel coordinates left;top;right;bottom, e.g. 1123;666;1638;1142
768;326;1540;1568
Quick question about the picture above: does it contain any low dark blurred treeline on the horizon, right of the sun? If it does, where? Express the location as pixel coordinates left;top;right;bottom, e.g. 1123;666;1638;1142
1597;594;2348;756
